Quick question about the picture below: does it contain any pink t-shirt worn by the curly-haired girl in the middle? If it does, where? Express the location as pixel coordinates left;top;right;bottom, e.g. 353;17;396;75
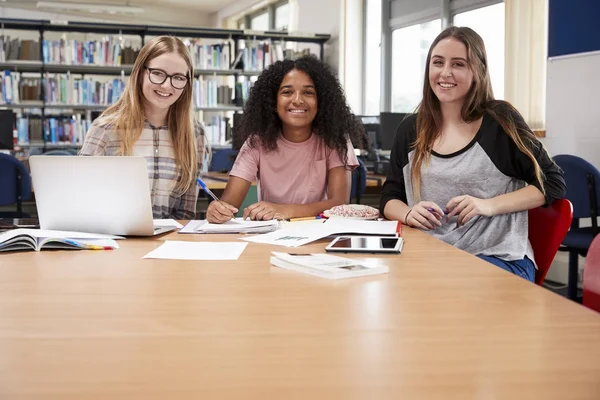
230;134;358;204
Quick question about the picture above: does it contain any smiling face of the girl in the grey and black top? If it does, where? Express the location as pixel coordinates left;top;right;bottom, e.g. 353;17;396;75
429;37;473;103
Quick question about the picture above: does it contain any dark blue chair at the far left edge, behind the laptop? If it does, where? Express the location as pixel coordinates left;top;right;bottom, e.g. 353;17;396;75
0;153;31;218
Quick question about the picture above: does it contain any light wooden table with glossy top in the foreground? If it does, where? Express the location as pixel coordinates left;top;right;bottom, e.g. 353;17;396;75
0;229;600;400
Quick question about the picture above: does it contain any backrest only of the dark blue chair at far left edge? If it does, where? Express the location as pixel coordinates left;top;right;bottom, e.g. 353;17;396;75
0;153;31;206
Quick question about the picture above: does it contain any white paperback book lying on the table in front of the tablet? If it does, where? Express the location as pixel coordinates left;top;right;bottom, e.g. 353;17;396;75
271;251;389;279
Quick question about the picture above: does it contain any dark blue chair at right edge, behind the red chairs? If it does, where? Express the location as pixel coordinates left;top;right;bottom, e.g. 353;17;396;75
554;154;600;300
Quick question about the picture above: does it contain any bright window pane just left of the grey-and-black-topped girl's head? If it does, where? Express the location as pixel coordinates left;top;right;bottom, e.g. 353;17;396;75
391;19;442;113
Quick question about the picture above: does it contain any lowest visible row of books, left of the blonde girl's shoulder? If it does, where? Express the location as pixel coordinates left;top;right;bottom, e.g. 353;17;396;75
16;115;92;145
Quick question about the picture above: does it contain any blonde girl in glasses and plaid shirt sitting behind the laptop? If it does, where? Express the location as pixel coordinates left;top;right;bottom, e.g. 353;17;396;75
79;36;207;219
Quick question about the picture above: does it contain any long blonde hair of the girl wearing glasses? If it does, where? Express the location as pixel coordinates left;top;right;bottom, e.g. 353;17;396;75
97;36;199;193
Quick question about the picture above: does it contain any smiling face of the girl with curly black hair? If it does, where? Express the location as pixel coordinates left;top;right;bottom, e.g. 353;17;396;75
277;69;317;128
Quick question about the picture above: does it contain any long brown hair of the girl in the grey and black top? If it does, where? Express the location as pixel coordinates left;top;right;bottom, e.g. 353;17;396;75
411;26;544;201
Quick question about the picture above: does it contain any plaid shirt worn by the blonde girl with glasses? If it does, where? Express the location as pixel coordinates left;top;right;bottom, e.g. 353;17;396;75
79;121;206;219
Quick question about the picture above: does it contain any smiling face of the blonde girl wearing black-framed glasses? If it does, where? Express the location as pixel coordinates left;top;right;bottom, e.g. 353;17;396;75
142;53;189;110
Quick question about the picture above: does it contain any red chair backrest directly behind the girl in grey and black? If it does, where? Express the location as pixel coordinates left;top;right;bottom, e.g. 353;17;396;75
529;199;573;285
